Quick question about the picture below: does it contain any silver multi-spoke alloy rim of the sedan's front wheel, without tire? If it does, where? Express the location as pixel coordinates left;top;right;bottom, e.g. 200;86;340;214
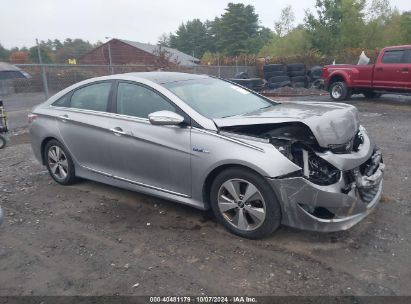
218;179;266;231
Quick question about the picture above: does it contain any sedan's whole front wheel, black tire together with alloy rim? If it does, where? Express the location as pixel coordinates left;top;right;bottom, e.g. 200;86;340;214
210;168;281;239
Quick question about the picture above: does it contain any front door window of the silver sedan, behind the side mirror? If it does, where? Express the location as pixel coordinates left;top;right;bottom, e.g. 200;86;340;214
117;82;176;118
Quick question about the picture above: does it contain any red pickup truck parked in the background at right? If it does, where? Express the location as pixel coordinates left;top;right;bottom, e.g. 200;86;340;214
323;45;411;101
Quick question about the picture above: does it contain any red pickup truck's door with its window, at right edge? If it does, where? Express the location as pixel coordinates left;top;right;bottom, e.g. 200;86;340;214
373;48;409;89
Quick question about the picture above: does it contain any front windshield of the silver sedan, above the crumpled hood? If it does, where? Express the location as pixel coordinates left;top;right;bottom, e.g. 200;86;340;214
164;78;275;119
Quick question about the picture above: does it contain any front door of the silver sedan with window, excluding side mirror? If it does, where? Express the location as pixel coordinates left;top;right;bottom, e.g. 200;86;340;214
110;81;191;196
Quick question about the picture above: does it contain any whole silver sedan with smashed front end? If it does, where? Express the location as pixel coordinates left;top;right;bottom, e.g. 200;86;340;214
29;72;384;238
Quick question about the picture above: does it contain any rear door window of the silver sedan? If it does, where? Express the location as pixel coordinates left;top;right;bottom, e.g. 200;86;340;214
70;82;112;112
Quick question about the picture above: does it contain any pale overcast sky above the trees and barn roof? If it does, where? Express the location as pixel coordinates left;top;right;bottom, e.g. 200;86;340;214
0;0;411;48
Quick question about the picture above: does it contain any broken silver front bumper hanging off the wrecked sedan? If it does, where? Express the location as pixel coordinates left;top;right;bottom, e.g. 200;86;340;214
268;152;384;232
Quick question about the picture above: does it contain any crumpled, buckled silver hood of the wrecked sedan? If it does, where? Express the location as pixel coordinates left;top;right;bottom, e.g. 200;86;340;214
214;102;359;147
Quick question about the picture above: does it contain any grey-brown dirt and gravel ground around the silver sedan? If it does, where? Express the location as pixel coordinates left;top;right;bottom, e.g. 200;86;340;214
0;92;411;295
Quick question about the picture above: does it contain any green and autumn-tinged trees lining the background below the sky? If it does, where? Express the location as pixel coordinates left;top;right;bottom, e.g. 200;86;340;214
0;0;411;64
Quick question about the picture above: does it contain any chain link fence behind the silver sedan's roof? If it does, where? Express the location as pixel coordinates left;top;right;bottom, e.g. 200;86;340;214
0;64;257;97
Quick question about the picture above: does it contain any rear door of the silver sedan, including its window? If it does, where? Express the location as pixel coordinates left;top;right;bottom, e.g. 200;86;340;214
53;81;114;172
